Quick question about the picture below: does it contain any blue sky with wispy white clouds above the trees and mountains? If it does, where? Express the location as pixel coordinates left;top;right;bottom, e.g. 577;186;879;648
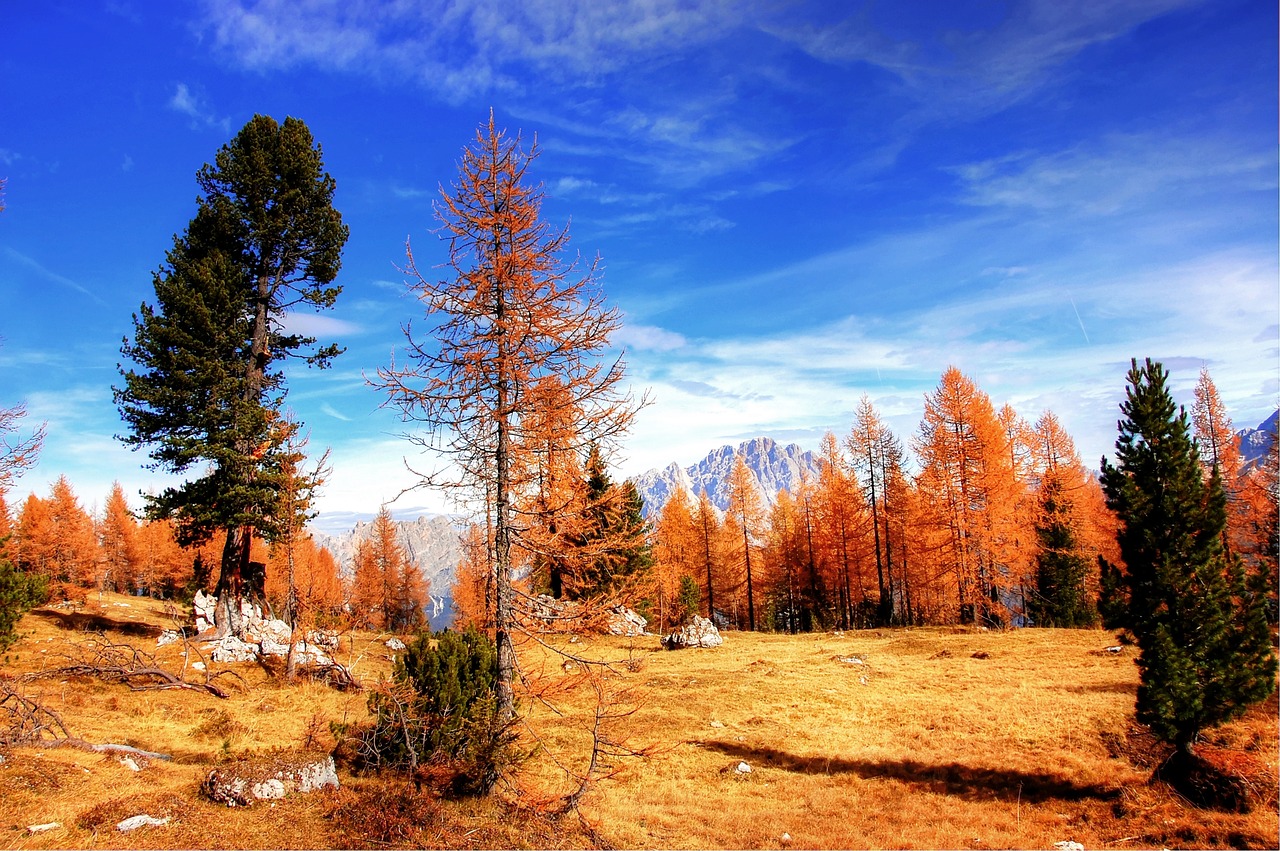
0;0;1280;524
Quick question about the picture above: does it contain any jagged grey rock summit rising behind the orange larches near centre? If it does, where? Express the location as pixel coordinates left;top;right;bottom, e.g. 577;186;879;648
634;438;818;520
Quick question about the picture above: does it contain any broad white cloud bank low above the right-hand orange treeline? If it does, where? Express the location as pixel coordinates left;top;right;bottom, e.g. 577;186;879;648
614;244;1280;475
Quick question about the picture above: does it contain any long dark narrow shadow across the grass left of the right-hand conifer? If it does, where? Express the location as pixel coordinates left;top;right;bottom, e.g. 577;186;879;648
698;741;1120;804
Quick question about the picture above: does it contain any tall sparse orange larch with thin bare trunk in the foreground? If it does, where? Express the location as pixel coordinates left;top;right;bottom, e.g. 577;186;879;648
376;114;636;719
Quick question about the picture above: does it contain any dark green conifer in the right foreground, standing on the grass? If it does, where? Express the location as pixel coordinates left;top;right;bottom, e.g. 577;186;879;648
1102;358;1276;782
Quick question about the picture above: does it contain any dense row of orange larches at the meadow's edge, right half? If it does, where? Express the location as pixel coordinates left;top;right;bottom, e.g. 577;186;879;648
644;367;1276;632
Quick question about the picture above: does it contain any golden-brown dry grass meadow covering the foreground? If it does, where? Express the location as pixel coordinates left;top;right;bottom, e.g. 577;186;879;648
0;595;1280;848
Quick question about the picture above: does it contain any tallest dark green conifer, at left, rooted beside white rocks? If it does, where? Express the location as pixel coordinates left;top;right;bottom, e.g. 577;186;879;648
115;115;347;631
